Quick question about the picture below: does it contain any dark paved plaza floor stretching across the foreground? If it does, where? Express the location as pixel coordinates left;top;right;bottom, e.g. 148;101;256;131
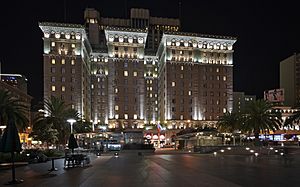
0;152;300;187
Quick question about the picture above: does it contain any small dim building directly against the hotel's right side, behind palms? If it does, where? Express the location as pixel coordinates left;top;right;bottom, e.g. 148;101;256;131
233;92;256;113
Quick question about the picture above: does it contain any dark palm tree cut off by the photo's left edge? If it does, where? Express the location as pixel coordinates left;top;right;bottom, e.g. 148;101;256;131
0;90;29;131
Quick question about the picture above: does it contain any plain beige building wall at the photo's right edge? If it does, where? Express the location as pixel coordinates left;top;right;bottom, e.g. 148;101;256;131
280;53;300;107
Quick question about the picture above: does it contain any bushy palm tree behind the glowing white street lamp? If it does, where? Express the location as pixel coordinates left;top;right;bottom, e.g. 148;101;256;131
35;96;79;144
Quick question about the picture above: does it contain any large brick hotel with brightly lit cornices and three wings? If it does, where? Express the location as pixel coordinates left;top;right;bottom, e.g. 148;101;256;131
39;8;236;137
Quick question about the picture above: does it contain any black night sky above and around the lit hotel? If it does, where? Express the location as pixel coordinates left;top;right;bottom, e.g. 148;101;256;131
0;0;300;102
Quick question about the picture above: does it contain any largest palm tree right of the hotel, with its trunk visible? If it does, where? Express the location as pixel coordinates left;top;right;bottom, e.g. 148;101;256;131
243;100;282;145
